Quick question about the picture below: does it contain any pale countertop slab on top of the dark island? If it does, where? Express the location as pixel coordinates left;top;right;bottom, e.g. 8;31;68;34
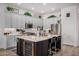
17;35;59;42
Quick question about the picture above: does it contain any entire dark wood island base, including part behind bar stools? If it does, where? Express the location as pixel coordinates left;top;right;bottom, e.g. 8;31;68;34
17;36;61;56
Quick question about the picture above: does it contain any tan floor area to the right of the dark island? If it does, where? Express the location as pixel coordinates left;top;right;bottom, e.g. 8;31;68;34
55;45;79;56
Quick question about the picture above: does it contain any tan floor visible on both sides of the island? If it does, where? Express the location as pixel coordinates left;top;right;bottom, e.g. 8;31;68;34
0;45;79;56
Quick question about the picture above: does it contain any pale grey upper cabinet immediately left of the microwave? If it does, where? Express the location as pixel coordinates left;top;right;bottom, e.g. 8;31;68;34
12;14;25;28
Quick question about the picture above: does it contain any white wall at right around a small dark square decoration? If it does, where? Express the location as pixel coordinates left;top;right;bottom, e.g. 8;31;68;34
61;6;78;46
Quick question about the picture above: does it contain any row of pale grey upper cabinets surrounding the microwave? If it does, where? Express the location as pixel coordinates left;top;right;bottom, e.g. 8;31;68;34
5;12;43;28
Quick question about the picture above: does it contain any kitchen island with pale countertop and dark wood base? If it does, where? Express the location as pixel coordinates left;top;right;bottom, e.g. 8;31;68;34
17;35;61;56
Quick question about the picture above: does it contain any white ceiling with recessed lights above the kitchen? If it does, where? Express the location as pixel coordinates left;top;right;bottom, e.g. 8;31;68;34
8;3;78;14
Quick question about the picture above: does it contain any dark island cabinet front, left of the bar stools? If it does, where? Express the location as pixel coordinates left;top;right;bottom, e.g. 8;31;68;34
17;39;48;56
